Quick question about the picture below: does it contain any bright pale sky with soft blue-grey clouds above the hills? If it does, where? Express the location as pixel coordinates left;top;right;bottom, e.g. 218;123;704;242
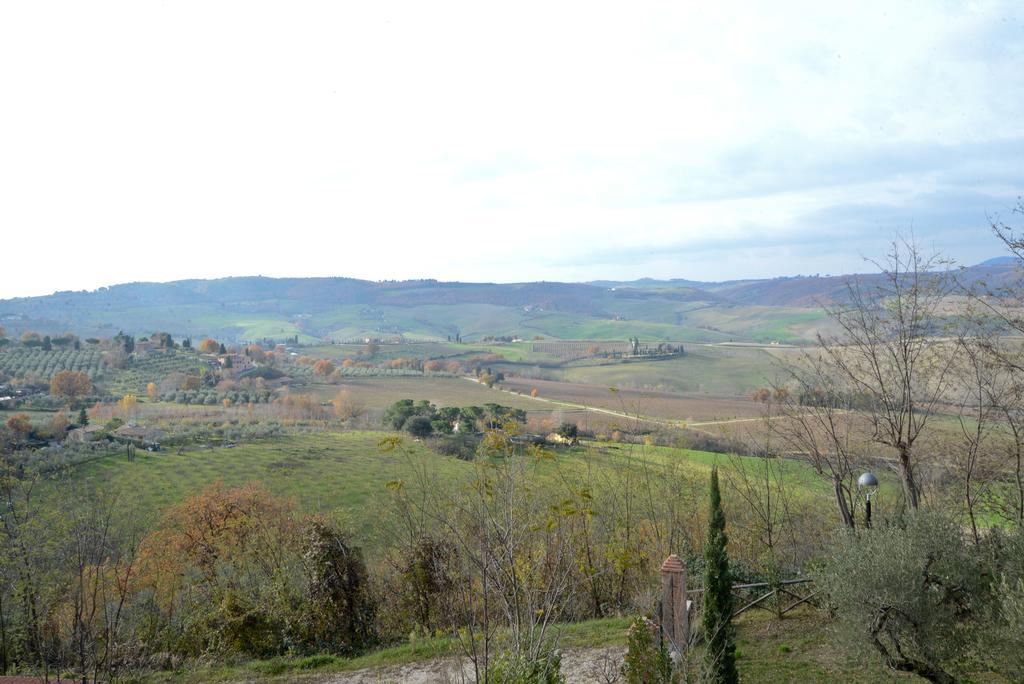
0;0;1024;298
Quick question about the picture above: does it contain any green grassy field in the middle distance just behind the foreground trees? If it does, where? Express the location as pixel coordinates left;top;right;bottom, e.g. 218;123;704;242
66;431;847;539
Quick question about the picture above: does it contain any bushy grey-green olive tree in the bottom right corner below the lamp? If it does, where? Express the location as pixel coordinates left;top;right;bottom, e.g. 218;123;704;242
819;510;1024;682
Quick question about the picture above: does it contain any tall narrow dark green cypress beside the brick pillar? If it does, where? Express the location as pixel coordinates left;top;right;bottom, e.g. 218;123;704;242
703;468;739;684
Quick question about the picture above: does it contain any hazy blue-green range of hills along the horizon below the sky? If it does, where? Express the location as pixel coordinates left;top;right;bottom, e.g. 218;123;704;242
0;257;1019;342
